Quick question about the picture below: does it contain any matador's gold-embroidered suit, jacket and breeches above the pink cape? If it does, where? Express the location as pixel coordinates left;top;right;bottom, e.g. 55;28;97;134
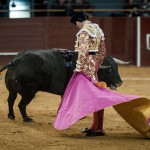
75;21;106;83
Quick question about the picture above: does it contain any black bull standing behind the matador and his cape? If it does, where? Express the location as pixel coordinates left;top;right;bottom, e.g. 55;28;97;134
0;50;122;122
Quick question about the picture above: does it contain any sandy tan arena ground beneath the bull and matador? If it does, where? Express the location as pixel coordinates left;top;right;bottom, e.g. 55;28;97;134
0;66;150;150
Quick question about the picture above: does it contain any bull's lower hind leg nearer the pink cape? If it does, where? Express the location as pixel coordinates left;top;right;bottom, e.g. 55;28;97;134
18;97;33;122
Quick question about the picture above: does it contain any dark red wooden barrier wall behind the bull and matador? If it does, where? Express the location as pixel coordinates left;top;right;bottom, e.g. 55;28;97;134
0;17;150;65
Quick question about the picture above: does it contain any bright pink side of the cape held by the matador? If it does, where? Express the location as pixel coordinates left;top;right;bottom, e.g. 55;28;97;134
54;73;139;130
